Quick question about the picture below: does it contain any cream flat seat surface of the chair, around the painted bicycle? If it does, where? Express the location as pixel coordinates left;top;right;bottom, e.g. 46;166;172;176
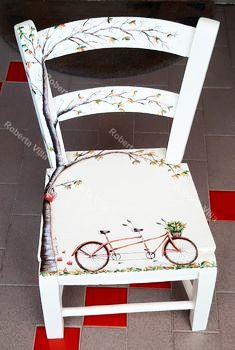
44;149;215;274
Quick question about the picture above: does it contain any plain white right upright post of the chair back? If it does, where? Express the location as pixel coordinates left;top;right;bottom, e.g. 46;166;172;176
166;18;219;164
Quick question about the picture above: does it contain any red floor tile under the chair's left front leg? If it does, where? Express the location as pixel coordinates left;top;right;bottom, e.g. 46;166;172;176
33;327;80;350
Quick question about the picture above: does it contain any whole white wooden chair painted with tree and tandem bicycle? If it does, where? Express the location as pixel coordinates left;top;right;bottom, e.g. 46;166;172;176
15;17;219;338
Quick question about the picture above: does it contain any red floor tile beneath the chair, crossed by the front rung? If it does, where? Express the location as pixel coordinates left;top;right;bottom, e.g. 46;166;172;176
83;287;127;327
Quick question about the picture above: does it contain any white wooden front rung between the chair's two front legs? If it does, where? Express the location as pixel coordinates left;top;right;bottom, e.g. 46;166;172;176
62;300;194;317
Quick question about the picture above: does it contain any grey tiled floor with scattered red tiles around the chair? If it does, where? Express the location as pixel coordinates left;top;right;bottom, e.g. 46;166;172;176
0;6;235;350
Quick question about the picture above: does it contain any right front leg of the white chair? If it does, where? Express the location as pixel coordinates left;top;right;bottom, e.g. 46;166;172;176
190;267;217;331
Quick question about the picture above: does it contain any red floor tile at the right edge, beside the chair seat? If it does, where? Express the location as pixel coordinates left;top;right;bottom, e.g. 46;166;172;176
210;191;235;220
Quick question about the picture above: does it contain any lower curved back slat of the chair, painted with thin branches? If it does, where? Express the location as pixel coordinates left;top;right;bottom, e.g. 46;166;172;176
54;86;178;121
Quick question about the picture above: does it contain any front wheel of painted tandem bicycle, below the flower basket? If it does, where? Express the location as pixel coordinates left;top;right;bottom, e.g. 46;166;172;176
163;237;198;265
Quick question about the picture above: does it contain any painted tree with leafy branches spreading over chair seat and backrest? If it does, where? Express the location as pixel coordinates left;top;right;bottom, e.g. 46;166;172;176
17;17;187;274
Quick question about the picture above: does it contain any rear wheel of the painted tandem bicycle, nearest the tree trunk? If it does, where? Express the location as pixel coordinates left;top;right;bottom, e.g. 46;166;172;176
75;241;109;272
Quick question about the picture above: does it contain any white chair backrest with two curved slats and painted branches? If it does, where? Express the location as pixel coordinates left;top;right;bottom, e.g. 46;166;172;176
15;17;219;167
